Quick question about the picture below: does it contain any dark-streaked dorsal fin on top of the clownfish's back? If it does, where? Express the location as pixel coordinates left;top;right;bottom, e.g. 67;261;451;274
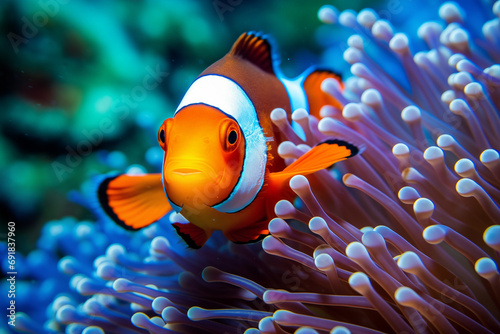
229;32;277;74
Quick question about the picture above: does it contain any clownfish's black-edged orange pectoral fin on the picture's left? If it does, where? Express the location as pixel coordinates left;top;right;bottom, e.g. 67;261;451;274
98;174;172;229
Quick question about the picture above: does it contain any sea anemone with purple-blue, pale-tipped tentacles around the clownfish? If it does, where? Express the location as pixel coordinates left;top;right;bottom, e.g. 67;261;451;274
4;1;500;334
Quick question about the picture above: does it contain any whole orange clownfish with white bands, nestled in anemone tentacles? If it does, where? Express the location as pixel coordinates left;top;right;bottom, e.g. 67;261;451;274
97;32;358;248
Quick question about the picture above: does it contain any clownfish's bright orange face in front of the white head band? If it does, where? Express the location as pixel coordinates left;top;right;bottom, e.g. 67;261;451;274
158;104;245;209
